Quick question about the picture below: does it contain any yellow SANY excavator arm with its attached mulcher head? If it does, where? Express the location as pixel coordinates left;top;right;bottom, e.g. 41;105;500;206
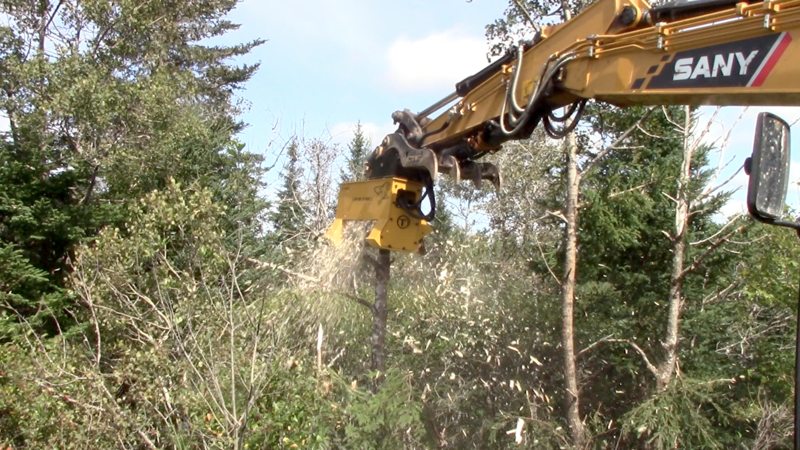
328;0;800;251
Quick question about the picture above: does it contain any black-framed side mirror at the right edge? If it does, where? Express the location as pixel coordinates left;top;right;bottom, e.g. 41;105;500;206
744;113;790;223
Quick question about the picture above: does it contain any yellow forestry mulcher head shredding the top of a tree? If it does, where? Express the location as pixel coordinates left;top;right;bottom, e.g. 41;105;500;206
326;177;433;252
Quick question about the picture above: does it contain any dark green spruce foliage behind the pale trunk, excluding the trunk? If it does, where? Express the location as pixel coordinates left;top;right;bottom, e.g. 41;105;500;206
576;105;732;444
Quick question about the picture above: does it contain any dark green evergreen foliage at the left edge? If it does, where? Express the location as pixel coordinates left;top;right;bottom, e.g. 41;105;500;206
0;140;94;334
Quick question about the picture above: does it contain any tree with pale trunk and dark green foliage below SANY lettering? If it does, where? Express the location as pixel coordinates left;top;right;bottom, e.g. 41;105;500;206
578;107;743;448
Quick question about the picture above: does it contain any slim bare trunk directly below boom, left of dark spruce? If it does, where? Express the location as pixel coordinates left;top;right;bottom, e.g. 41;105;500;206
561;133;584;449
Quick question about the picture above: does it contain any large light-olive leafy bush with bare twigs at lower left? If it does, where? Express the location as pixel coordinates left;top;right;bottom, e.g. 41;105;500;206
0;182;296;448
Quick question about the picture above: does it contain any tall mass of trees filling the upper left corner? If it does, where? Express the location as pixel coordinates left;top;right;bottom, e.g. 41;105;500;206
0;0;265;330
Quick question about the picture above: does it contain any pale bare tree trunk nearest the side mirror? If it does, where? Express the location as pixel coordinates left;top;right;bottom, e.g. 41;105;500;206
656;106;694;391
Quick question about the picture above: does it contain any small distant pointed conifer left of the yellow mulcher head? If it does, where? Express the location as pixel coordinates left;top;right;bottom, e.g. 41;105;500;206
270;139;307;247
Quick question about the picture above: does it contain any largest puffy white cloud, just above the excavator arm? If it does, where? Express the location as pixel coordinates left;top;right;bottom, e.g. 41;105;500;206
386;30;488;92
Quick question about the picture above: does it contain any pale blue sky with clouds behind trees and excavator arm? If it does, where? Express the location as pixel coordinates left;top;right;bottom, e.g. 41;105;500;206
215;0;800;221
